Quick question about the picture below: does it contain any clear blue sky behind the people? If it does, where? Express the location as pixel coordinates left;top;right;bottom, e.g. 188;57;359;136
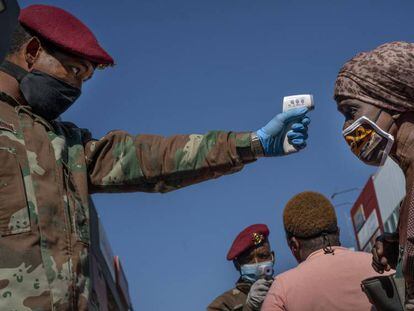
20;0;414;311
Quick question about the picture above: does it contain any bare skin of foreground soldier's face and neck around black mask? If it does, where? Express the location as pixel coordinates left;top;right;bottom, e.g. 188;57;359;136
0;37;95;103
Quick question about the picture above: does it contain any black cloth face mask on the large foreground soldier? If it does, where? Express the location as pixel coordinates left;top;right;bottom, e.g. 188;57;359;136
0;61;81;121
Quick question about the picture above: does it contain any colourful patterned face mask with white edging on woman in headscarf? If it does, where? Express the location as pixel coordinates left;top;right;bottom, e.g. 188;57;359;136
342;116;394;166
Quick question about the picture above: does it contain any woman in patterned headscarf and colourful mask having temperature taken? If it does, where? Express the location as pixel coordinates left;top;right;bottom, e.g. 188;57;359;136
335;42;414;310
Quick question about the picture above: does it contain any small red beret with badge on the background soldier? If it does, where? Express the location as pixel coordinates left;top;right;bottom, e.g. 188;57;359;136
227;224;269;260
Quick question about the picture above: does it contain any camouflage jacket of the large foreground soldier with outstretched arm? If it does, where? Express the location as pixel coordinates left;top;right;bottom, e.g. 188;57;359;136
0;93;254;311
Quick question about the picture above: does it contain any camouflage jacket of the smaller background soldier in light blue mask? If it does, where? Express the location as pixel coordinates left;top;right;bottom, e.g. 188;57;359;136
207;279;259;311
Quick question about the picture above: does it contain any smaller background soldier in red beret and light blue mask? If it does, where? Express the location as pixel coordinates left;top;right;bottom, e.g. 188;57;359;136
207;224;275;311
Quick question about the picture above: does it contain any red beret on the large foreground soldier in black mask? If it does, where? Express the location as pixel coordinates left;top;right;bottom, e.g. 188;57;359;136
19;4;114;66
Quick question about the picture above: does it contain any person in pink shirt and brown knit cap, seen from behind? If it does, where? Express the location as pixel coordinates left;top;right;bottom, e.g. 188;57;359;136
261;192;384;311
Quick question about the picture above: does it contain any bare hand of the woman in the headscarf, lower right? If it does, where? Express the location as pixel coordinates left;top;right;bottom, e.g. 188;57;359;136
371;233;399;273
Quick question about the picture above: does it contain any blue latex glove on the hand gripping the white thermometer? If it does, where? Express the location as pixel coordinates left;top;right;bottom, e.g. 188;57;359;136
256;107;310;156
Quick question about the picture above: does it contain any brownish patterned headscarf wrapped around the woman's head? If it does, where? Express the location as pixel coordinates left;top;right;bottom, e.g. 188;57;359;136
334;42;414;112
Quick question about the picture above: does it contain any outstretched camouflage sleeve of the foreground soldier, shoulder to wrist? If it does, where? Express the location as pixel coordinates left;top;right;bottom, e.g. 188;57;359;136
84;131;255;192
